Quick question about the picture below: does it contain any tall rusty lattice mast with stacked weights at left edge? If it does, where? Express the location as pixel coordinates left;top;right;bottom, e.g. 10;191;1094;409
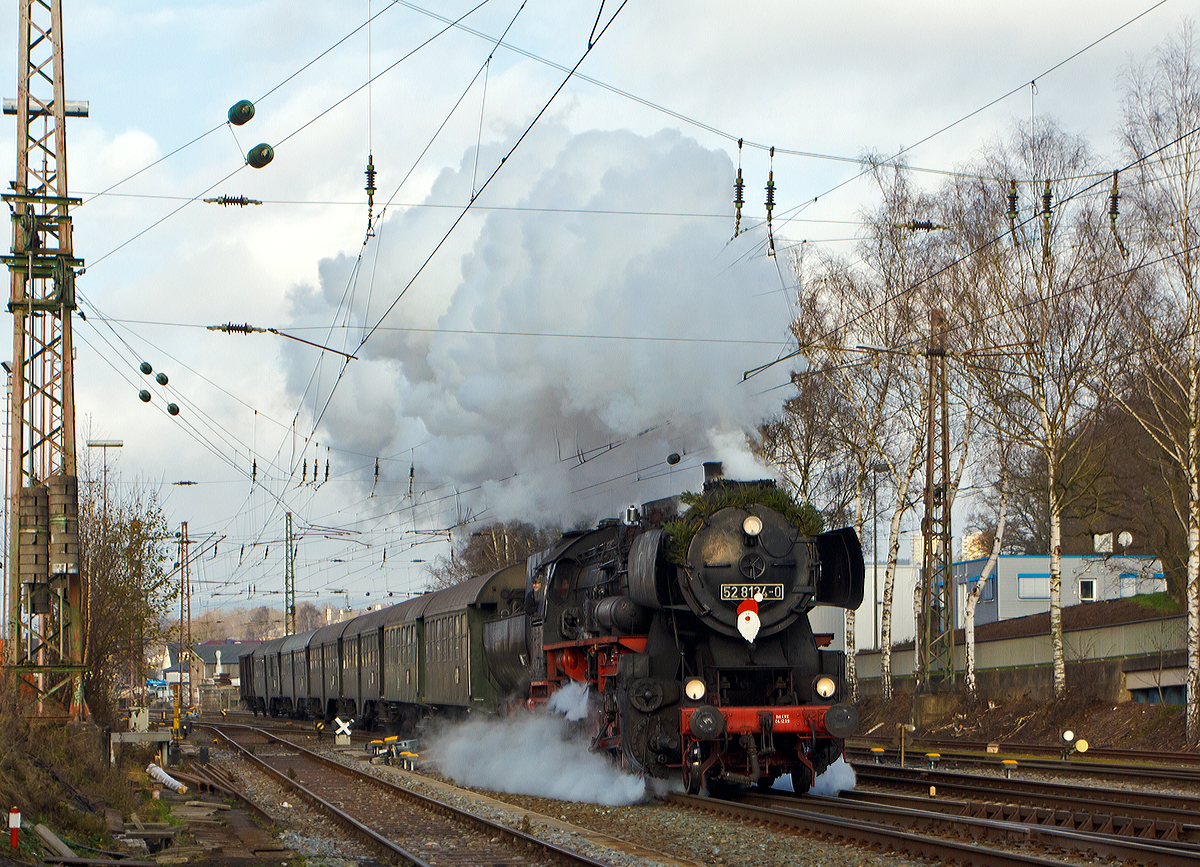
2;0;88;718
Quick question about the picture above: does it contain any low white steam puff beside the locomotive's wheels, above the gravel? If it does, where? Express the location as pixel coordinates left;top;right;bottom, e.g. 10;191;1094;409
425;683;646;806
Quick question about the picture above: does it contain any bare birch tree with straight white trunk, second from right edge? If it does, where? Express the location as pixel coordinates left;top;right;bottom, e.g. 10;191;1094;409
940;120;1117;696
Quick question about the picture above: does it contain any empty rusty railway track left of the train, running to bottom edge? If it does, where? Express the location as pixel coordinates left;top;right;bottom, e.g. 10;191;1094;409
205;723;612;867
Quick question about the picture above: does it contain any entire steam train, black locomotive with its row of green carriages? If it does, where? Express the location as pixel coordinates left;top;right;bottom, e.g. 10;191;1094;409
241;464;864;793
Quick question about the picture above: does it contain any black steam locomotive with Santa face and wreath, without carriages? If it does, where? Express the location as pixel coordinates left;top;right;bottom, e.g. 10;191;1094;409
482;465;864;793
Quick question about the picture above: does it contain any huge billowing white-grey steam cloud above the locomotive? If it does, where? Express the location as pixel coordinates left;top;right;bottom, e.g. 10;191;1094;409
288;124;790;525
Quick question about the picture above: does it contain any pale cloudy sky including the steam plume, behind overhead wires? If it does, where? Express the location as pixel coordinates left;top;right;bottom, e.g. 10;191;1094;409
0;0;1193;611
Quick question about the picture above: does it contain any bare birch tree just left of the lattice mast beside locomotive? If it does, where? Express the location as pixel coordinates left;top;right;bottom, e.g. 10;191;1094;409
792;167;965;700
